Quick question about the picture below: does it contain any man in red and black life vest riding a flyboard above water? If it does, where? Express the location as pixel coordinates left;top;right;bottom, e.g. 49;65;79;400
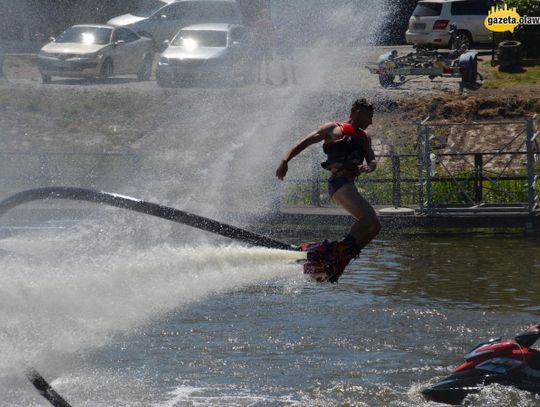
276;99;381;282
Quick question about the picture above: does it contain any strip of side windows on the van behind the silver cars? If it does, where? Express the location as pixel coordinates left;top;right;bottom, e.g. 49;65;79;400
161;1;237;22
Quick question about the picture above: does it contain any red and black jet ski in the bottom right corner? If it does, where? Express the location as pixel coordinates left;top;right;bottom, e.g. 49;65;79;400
422;324;540;405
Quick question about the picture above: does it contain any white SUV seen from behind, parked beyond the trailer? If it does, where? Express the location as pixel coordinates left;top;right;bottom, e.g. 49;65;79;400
405;0;492;48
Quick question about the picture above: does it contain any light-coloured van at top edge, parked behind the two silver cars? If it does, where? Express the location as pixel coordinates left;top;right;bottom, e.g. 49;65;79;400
107;0;242;44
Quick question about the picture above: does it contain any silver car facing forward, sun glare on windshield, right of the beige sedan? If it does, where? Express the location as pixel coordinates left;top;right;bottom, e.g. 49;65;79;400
156;24;255;86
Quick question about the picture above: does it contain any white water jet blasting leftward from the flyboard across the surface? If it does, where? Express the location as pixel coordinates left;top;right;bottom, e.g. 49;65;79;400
0;237;299;374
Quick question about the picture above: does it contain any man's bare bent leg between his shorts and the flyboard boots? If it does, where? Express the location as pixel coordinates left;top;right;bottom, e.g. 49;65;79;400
332;183;381;249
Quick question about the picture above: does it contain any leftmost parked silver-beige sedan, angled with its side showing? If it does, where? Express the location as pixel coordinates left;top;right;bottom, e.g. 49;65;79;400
37;25;154;83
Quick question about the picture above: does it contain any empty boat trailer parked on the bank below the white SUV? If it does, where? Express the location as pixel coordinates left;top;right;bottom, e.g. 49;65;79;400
366;50;478;87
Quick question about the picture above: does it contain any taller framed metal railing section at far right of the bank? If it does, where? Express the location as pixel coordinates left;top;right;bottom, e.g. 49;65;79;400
417;117;540;213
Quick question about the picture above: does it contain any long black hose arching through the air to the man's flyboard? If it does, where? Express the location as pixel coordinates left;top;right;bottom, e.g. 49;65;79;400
0;187;299;250
